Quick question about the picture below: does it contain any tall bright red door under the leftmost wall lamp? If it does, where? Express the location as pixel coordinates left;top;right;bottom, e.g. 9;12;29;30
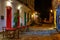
6;6;12;29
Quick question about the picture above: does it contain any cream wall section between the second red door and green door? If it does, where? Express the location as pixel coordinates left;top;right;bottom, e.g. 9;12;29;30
20;5;31;26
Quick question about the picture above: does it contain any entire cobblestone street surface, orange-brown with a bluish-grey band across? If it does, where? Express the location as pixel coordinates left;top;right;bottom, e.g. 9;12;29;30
0;25;60;40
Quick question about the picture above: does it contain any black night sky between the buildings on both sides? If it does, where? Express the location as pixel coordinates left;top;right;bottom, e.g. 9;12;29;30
34;0;52;17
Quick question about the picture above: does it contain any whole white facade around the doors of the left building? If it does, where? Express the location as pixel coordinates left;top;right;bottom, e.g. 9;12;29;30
0;0;31;31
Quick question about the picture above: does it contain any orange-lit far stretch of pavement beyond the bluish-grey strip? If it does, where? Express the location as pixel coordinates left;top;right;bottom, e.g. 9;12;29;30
29;24;55;30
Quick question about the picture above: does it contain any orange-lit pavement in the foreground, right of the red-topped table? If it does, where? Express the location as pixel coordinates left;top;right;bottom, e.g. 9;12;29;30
21;34;60;40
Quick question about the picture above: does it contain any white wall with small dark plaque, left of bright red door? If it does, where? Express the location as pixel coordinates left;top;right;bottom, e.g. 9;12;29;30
0;0;5;32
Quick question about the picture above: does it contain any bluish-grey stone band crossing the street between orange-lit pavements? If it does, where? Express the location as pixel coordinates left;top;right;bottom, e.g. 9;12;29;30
24;30;57;35
